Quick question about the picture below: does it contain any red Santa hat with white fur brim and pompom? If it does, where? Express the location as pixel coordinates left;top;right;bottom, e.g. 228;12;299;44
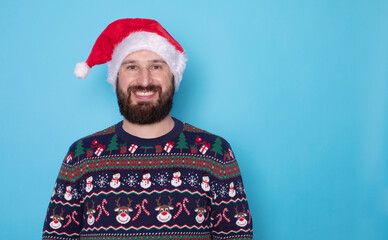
74;18;187;90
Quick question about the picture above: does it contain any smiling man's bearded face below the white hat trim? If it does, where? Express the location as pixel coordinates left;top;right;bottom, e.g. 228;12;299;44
116;50;175;124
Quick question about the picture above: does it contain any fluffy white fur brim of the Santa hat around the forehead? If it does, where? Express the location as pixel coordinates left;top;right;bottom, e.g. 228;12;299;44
108;32;187;90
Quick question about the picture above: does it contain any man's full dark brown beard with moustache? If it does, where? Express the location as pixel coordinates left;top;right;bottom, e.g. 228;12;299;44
116;79;175;124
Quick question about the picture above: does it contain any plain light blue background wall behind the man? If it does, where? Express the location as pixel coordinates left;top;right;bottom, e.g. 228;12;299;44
0;0;388;240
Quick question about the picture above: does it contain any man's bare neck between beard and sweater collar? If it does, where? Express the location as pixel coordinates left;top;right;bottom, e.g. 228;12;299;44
123;114;175;139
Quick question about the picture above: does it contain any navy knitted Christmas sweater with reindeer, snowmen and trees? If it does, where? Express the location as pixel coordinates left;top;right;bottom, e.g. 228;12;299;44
42;118;253;240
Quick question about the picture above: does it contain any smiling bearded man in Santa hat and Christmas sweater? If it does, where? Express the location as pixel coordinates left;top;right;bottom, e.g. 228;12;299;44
43;19;252;239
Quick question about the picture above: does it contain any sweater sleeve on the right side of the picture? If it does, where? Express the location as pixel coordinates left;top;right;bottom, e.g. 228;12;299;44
211;142;253;240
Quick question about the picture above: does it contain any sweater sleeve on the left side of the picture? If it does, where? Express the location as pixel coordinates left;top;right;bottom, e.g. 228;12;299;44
42;144;83;240
